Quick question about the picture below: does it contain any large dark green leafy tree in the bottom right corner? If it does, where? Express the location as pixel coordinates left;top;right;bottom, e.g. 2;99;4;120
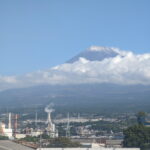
123;124;150;150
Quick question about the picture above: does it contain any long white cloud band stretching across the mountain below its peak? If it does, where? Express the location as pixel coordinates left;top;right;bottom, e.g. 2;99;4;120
0;46;150;90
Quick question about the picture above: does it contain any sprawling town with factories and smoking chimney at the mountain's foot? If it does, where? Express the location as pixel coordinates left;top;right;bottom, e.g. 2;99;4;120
0;103;150;149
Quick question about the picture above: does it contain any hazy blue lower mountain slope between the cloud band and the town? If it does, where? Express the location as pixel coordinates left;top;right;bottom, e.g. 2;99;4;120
0;84;150;112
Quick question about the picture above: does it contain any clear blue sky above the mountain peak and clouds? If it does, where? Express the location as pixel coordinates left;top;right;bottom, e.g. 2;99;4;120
0;0;150;75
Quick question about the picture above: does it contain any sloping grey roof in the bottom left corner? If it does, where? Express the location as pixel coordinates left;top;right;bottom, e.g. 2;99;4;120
0;140;33;150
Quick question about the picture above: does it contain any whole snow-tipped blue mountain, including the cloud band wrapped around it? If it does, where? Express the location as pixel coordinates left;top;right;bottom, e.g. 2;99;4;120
0;46;150;110
